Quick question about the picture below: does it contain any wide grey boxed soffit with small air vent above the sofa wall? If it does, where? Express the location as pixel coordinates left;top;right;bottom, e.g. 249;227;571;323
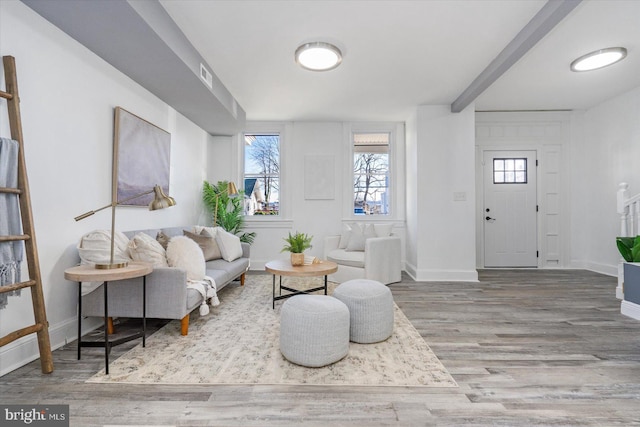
21;0;246;135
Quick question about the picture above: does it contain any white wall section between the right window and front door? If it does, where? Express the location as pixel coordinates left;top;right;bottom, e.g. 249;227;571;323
406;105;478;281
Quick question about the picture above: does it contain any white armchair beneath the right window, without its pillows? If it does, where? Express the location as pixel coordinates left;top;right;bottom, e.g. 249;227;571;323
324;235;402;285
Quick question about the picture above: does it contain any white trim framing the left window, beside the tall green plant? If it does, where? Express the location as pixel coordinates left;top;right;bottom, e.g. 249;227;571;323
235;122;293;228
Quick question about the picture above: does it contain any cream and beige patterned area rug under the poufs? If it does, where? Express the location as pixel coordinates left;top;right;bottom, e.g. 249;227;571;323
88;275;457;387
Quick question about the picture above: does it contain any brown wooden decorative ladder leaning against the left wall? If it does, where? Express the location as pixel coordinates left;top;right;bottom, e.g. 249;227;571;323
0;56;53;374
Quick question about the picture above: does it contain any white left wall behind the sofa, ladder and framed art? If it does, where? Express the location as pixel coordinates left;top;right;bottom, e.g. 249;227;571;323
0;0;211;375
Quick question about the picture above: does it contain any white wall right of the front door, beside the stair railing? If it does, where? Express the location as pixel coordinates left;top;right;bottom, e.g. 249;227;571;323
571;87;640;275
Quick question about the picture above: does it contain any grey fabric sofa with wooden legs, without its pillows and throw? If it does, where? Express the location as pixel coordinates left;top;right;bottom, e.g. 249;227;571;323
82;226;250;335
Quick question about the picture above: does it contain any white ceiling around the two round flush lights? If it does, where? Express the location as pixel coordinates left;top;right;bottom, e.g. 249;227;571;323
160;0;640;121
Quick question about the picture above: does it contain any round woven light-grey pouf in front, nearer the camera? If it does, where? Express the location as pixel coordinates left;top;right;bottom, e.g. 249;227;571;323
280;295;349;368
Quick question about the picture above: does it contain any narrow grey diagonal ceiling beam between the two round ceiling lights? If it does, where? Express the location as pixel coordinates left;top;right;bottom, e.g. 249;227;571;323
451;0;582;113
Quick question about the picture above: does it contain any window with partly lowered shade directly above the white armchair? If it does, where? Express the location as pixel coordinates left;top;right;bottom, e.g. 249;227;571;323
353;132;391;215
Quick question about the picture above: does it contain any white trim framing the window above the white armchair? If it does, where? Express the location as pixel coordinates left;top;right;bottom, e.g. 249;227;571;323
342;122;405;223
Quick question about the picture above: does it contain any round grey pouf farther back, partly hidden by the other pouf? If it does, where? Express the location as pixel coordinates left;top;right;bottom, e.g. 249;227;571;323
333;279;393;344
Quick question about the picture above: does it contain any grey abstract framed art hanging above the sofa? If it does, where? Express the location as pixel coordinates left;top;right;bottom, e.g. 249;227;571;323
112;107;171;206
